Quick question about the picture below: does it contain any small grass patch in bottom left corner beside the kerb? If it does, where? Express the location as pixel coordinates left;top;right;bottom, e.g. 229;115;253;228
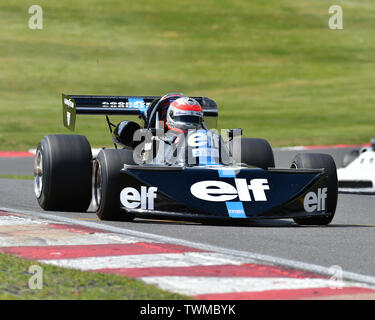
0;253;191;300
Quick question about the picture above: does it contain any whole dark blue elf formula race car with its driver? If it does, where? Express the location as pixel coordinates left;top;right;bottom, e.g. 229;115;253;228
34;93;338;225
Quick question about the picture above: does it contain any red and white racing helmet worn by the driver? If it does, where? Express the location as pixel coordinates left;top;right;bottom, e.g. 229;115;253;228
167;97;203;132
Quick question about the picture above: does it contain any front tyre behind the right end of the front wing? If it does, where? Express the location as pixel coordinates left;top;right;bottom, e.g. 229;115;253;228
291;153;338;225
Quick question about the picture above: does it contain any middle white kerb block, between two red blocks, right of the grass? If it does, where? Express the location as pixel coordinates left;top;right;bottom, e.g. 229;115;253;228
39;252;254;270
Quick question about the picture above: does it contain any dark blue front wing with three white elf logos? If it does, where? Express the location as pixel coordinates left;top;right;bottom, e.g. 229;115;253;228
120;165;328;219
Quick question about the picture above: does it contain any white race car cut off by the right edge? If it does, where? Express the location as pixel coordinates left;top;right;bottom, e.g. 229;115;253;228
337;138;375;194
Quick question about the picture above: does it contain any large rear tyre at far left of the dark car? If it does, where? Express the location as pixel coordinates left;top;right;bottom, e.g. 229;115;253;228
34;135;92;212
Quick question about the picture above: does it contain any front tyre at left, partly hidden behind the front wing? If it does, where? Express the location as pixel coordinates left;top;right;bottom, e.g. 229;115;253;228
93;149;135;221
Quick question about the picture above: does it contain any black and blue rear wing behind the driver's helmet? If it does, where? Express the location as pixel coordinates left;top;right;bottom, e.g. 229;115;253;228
62;94;218;131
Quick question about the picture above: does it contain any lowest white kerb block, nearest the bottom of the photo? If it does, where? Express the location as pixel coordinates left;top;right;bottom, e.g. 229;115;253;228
140;276;362;295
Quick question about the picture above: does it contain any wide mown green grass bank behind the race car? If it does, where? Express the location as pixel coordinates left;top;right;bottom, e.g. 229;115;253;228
0;0;375;150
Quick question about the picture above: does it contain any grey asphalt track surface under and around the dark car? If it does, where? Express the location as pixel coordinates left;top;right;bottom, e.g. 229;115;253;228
0;148;375;281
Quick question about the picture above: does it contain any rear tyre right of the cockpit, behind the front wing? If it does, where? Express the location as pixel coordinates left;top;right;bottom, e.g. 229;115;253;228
233;138;275;169
